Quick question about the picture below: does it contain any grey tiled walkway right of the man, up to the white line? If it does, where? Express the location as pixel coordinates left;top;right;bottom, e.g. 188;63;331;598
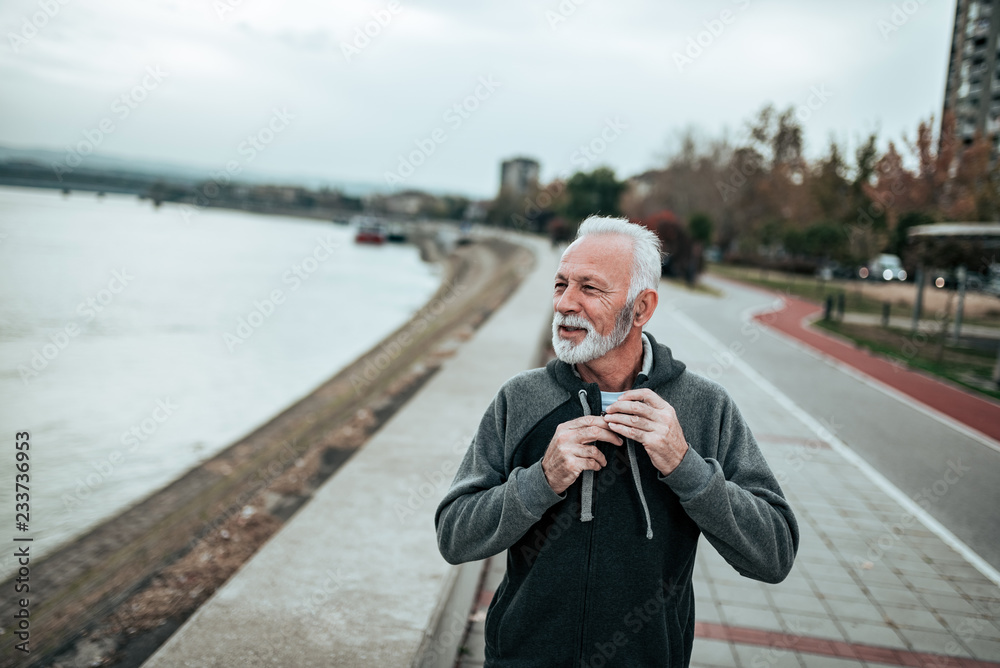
458;276;1000;668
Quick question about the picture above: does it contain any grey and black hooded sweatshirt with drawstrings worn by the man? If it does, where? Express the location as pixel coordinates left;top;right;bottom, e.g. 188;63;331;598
435;332;799;668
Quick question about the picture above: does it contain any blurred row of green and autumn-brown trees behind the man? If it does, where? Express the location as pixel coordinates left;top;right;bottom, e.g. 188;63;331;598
490;105;1000;272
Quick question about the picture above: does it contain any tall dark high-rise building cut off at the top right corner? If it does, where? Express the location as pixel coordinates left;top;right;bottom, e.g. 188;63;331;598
944;0;1000;150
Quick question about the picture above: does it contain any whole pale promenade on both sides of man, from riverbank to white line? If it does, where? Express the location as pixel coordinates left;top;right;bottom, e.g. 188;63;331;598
144;234;1000;668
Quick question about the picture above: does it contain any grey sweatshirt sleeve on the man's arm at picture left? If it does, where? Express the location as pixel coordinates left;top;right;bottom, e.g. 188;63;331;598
434;389;566;564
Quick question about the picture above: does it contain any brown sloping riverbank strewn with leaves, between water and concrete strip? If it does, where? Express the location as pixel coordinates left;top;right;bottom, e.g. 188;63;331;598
0;225;532;666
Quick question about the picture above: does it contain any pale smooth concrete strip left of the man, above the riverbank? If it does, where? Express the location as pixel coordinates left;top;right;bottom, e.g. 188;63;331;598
144;231;558;668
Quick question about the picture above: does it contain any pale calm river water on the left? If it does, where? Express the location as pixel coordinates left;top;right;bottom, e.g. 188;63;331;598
0;188;441;577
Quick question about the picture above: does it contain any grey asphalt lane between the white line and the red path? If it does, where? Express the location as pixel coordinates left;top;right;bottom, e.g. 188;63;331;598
651;277;1000;569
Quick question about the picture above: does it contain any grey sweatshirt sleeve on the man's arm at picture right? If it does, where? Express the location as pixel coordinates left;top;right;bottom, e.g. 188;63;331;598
658;395;799;583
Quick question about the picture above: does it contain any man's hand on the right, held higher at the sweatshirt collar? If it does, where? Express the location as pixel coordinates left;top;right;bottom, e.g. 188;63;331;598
604;388;688;475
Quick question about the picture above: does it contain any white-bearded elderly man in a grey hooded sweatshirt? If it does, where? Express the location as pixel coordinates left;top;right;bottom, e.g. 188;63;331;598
435;217;799;668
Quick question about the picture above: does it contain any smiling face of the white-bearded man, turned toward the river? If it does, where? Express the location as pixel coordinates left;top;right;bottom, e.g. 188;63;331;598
552;235;632;364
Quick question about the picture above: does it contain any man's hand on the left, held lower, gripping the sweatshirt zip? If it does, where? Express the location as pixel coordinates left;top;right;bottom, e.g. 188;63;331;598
542;415;625;494
